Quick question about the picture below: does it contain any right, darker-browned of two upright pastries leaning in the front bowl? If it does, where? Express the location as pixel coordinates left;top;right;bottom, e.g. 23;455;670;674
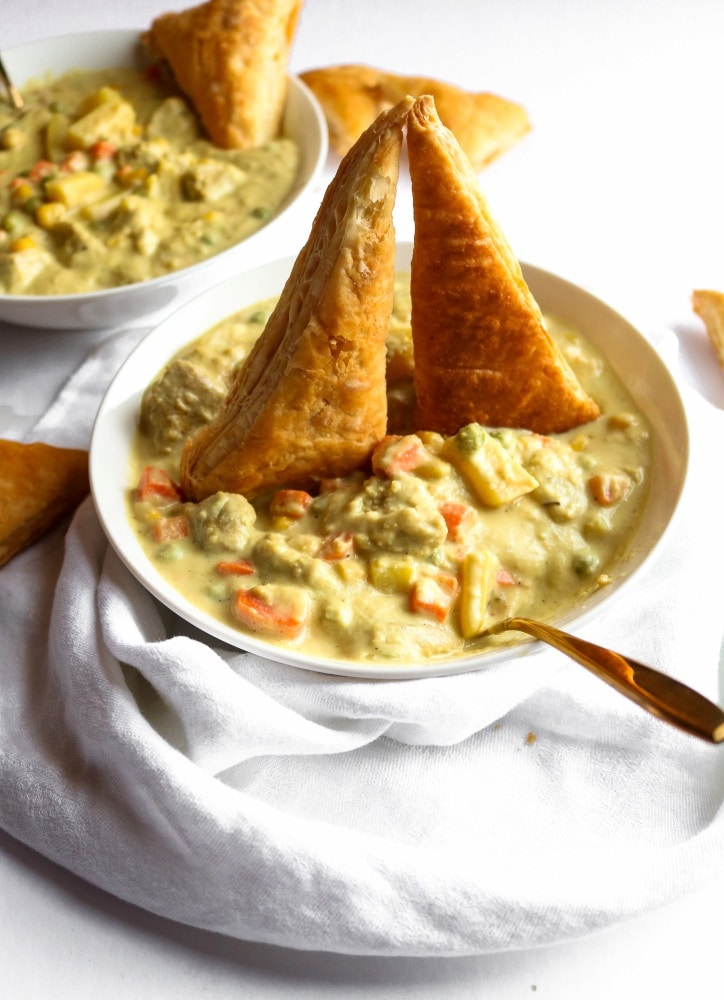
407;96;599;434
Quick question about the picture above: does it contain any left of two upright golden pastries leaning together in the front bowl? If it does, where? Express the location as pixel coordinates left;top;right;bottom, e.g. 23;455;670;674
181;99;412;500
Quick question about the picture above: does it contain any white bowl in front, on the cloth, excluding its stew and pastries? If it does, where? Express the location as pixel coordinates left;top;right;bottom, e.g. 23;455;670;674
90;244;689;679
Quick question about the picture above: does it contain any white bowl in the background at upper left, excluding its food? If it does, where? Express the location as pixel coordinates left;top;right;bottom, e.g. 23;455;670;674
0;30;327;330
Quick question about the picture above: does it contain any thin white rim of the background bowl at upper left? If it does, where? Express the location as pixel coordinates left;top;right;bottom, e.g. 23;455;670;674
0;28;329;312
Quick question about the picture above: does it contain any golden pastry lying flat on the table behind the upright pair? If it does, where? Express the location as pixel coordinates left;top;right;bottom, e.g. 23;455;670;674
300;65;531;170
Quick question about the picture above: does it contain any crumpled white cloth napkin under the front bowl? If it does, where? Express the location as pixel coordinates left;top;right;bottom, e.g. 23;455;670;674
0;331;724;955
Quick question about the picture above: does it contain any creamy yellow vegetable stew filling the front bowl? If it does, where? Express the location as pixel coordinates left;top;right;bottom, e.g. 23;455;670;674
129;275;651;662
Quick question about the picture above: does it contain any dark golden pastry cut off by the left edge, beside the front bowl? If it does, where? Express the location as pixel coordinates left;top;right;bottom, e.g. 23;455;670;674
0;440;89;566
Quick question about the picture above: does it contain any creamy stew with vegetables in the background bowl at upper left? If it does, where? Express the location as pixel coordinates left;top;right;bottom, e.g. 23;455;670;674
0;67;299;295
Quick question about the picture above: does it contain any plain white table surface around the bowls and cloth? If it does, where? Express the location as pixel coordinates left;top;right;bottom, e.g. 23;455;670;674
0;0;724;1000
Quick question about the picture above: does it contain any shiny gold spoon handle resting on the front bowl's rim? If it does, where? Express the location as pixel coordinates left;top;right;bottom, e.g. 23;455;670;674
481;618;724;743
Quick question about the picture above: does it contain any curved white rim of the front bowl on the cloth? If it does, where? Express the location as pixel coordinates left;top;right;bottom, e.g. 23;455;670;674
89;242;689;680
